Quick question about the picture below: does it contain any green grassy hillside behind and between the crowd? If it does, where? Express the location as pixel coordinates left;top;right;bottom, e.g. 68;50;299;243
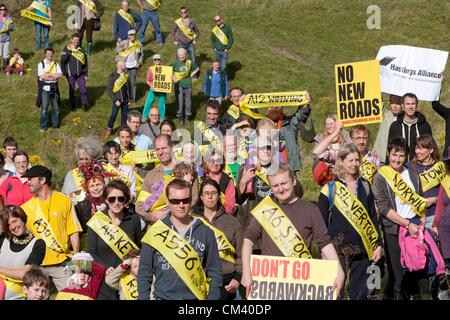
0;0;450;200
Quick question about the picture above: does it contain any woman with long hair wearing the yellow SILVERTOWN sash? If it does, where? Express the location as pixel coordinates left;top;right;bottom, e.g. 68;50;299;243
319;144;383;300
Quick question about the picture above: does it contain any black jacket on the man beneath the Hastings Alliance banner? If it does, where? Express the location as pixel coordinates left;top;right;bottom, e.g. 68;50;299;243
388;111;433;161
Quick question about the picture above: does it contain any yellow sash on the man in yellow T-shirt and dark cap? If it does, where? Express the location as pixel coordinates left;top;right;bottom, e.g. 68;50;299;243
22;195;70;255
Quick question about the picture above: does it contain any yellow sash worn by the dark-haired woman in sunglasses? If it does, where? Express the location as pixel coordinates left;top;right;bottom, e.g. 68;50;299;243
87;211;139;260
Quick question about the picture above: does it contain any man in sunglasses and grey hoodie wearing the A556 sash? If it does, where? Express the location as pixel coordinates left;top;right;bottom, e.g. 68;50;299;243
137;179;222;300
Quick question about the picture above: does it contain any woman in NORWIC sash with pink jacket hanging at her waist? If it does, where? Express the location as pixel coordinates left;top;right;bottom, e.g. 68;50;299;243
373;137;445;300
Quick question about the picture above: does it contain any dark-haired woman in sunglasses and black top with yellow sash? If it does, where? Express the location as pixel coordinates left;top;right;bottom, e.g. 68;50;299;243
87;180;142;300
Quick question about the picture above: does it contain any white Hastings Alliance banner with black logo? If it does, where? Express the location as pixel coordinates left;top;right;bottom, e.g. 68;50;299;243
377;45;448;101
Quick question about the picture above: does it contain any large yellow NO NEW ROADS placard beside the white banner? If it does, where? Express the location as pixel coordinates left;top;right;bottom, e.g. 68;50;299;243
335;60;383;127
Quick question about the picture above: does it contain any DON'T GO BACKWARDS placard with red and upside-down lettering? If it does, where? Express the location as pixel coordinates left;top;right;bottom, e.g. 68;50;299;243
248;255;339;300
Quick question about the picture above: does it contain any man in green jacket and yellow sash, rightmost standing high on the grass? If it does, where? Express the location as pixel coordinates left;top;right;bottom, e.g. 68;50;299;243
211;16;233;72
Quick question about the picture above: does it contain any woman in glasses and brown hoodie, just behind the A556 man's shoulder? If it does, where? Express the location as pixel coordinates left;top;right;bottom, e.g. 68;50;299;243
193;179;243;300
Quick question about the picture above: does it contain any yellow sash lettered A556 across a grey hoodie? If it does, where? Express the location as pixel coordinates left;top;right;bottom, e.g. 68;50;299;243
142;220;209;300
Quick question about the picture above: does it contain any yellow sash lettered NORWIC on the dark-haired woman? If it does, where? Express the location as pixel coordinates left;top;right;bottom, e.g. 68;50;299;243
378;166;427;217
